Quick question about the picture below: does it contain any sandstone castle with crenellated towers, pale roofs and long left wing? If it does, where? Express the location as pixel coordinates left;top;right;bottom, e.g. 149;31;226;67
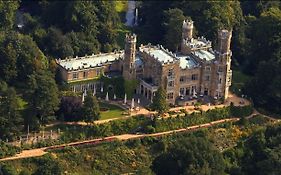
57;20;232;105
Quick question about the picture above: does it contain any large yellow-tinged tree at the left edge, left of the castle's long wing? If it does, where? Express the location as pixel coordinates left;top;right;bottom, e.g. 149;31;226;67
0;31;48;84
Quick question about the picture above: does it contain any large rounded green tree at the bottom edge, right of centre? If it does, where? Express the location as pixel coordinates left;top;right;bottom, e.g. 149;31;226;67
151;136;225;175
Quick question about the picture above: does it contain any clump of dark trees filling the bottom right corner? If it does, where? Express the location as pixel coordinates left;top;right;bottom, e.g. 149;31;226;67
226;124;281;175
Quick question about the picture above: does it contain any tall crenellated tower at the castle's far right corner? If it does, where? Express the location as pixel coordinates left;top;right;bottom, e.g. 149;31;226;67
213;29;232;99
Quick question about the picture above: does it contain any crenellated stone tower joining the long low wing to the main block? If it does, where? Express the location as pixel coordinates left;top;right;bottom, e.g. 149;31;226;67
122;34;137;80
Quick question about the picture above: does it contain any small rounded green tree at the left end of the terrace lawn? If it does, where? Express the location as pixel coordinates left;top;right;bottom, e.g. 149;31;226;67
82;95;100;123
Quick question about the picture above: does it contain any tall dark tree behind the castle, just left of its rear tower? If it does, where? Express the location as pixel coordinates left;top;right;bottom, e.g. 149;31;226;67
163;8;185;51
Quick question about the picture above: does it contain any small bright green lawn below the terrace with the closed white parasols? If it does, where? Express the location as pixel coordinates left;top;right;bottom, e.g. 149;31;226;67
100;102;125;120
